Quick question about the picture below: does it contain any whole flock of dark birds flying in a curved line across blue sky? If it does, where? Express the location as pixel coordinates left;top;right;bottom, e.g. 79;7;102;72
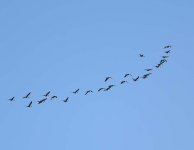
9;45;172;108
